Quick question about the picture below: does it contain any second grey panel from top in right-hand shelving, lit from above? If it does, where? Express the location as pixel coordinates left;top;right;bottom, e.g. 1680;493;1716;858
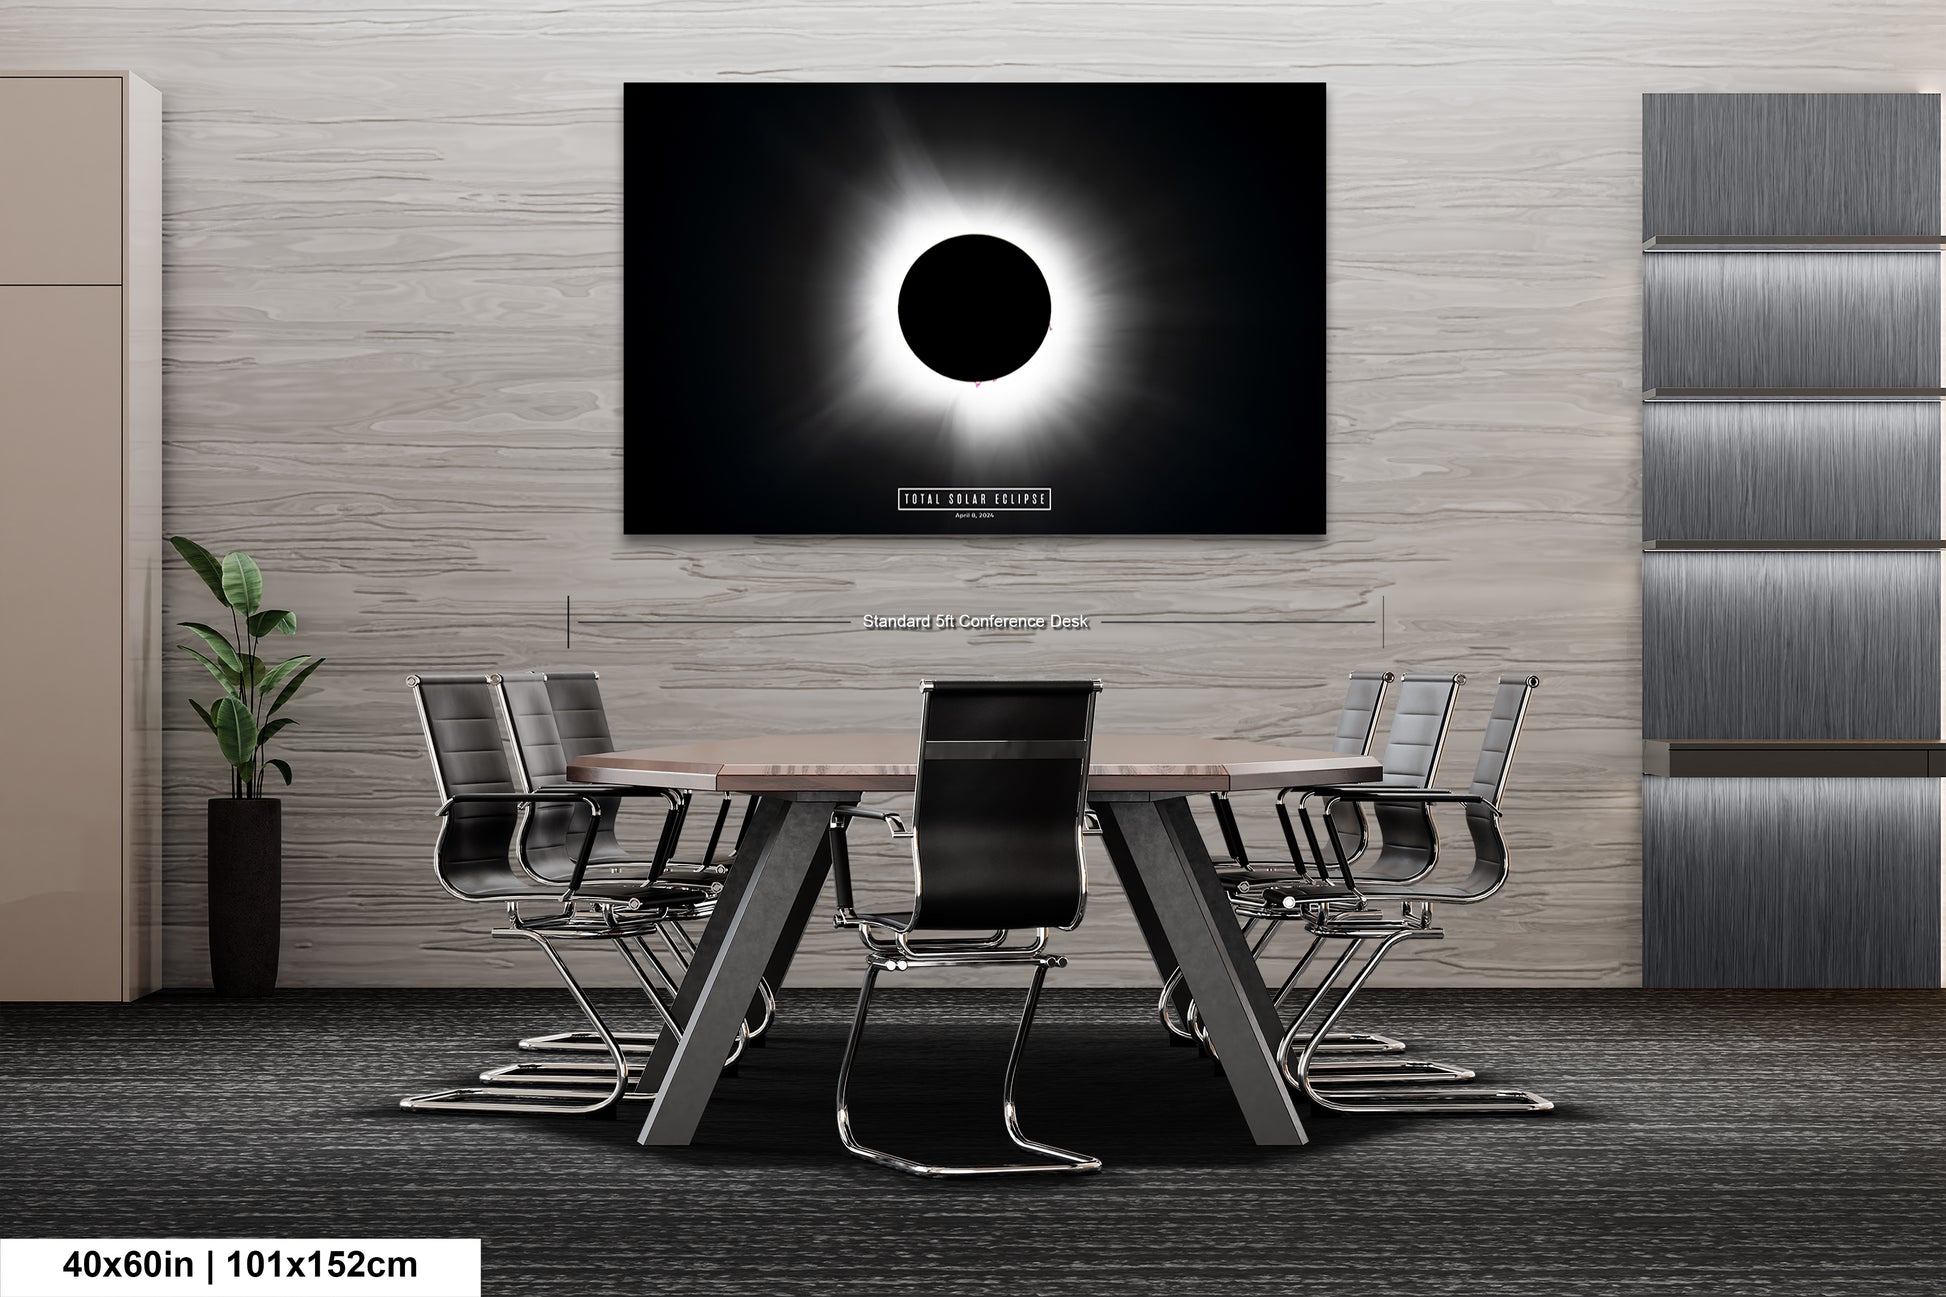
1642;253;1940;388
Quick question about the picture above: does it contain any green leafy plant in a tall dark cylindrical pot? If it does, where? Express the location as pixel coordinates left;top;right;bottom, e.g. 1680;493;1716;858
169;536;325;995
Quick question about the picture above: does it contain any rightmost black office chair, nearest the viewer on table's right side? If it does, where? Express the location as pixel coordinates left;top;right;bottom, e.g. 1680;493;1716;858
1261;676;1553;1112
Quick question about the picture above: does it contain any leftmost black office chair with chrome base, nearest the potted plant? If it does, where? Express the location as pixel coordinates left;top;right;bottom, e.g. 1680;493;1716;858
401;676;710;1114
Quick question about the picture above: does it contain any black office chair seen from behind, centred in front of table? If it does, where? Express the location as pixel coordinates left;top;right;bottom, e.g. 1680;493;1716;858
831;680;1101;1176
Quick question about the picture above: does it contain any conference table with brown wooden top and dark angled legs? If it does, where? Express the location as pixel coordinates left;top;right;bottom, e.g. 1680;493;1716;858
568;732;1380;1145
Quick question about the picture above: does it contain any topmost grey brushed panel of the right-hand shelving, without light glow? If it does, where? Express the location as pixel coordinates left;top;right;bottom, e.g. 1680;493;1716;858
1642;95;1940;238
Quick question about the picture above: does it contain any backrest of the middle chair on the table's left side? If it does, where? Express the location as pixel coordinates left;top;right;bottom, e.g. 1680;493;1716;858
492;672;625;882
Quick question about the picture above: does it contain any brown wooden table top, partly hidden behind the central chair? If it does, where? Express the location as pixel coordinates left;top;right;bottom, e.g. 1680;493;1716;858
568;732;1380;793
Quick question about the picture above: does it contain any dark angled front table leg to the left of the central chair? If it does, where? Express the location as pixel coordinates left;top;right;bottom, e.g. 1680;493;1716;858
636;793;858;1143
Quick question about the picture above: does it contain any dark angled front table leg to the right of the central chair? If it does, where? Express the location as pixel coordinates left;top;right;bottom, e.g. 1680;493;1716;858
1090;797;1306;1145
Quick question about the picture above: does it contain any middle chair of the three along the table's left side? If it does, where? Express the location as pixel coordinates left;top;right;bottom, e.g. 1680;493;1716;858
488;672;776;1075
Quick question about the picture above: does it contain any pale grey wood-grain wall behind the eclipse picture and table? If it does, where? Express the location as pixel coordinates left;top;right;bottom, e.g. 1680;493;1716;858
15;0;1946;985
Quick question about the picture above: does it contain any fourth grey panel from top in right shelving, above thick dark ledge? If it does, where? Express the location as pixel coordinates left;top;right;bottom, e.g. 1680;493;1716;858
1642;553;1940;738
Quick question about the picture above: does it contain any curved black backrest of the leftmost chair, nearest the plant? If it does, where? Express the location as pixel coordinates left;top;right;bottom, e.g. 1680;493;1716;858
405;674;525;900
